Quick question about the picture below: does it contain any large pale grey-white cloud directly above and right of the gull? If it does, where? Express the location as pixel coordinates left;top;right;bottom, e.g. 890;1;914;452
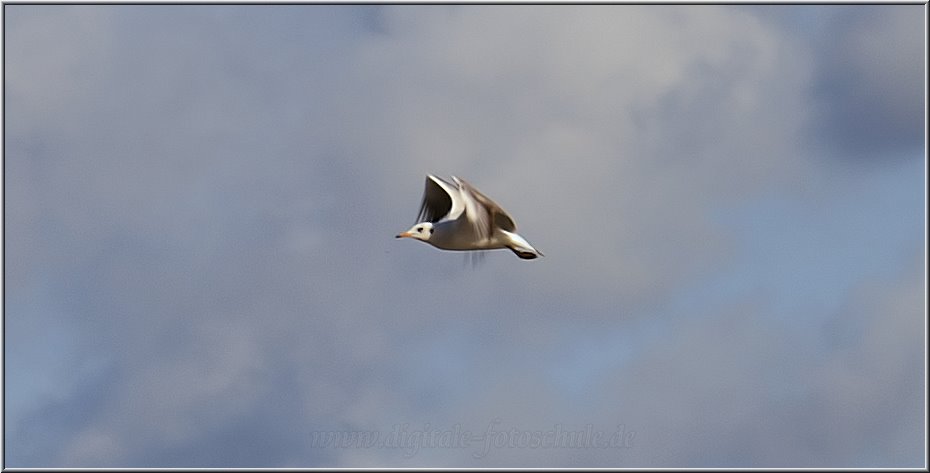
338;6;807;310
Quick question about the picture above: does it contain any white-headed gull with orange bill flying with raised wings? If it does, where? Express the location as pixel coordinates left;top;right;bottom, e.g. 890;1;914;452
396;174;543;259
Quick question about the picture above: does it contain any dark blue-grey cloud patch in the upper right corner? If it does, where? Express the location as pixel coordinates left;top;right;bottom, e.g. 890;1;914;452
814;5;927;158
